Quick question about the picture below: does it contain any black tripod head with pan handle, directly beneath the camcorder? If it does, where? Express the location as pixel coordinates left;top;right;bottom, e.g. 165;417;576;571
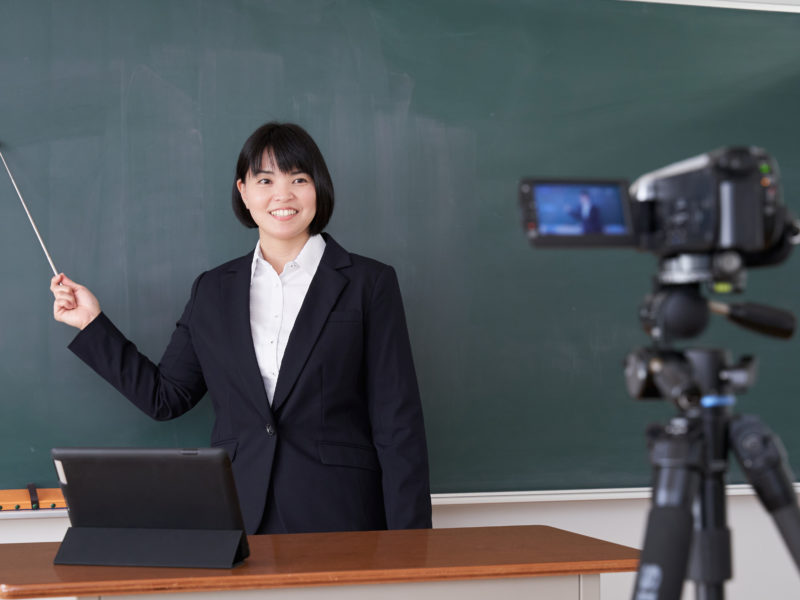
625;246;797;410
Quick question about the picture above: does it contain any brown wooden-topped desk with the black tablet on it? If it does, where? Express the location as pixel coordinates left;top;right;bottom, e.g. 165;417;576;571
0;525;639;600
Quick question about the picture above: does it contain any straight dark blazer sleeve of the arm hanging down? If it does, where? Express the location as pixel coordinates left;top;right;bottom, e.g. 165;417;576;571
365;266;431;529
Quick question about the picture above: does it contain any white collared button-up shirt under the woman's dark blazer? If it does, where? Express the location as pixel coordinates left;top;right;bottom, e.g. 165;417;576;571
250;235;325;404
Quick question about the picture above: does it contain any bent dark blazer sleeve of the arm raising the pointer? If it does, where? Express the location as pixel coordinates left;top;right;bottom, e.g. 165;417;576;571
69;275;206;421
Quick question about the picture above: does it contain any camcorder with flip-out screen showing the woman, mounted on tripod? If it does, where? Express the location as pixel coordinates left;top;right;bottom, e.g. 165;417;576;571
520;147;793;270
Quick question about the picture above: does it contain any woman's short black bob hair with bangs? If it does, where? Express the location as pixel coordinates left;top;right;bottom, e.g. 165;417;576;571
231;121;333;235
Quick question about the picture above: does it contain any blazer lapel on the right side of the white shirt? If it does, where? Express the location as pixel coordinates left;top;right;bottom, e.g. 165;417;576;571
272;234;350;411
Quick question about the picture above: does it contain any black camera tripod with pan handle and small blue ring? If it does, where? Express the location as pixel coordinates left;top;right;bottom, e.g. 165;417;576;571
626;286;800;600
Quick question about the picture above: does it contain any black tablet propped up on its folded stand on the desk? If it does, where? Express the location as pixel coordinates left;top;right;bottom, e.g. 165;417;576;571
52;448;249;566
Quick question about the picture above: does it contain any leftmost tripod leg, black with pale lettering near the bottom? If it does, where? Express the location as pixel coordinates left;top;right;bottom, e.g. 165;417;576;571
633;419;702;600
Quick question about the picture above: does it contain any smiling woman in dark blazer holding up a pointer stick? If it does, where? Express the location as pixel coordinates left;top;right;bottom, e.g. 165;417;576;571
50;123;431;533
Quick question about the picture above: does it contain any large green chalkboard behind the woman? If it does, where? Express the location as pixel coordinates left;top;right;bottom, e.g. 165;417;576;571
0;0;800;492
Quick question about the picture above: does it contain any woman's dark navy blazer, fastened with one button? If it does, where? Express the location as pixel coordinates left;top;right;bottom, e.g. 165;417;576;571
70;235;431;533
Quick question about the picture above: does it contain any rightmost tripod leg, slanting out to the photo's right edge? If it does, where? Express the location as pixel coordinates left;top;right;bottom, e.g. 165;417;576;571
730;415;800;570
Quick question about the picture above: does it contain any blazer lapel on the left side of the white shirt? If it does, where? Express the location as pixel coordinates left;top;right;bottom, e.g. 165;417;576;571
222;254;273;423
